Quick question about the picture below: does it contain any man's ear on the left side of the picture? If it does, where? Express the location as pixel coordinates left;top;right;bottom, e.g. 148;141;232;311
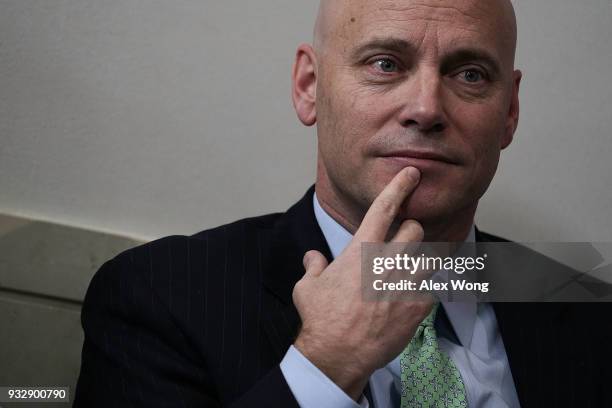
291;44;317;126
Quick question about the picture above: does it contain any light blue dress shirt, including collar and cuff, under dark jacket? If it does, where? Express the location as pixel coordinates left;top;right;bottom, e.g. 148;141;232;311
280;194;519;408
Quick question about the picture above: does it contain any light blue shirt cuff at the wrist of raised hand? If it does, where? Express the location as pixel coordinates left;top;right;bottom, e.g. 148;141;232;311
280;346;370;408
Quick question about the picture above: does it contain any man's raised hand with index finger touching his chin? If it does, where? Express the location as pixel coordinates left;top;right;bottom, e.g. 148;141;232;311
293;167;432;400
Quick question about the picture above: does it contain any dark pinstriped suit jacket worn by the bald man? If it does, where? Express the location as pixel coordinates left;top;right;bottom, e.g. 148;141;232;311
74;188;612;408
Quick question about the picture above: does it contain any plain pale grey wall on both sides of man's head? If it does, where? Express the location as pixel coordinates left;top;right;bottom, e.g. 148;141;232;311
0;0;612;241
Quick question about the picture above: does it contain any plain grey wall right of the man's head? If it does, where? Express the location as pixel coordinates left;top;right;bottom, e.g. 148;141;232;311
478;0;612;241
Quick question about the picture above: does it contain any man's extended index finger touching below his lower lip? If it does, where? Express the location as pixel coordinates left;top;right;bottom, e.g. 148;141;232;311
355;167;421;242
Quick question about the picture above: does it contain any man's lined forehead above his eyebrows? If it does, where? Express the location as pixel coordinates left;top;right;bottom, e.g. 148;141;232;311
332;0;514;60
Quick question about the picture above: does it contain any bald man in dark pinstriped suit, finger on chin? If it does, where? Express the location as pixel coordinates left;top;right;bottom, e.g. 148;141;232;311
75;0;611;407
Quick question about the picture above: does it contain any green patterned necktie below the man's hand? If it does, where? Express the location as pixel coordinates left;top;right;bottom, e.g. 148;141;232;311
400;303;467;408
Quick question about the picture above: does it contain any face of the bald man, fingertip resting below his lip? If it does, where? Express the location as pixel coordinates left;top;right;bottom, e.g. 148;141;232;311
315;0;520;228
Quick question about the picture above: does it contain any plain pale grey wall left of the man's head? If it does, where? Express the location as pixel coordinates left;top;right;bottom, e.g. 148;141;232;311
0;0;315;242
